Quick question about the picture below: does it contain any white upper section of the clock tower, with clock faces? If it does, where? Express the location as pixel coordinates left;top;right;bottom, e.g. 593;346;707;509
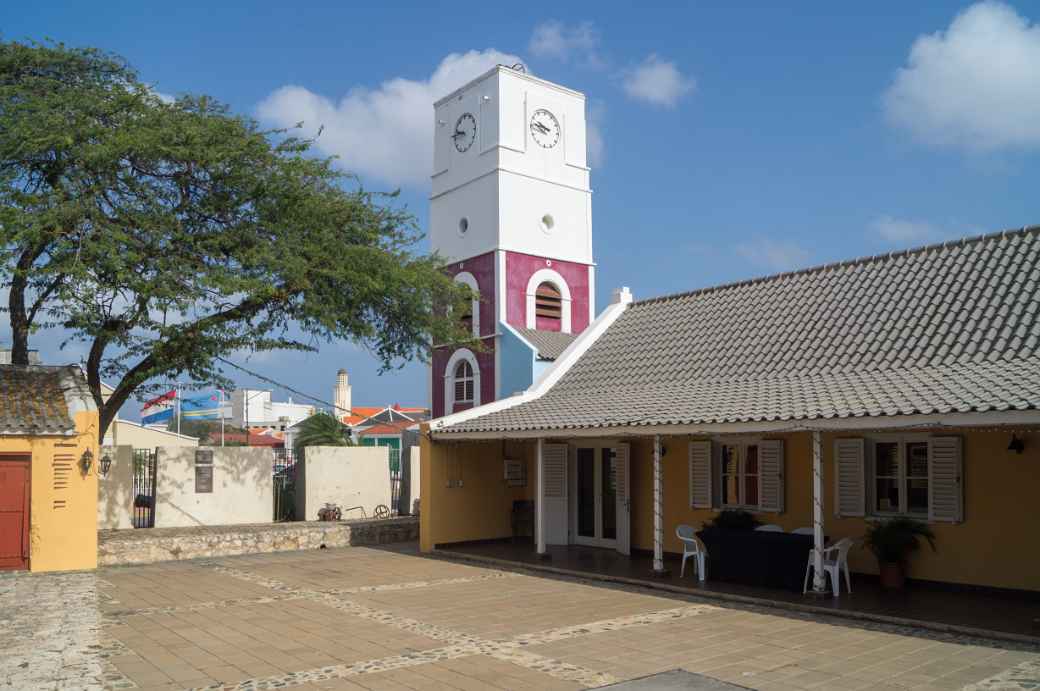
430;66;593;264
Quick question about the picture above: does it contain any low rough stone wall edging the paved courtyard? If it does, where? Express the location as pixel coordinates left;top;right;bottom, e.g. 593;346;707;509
98;516;419;566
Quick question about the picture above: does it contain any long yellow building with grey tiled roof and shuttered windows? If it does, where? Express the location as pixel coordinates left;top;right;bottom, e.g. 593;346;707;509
421;228;1040;591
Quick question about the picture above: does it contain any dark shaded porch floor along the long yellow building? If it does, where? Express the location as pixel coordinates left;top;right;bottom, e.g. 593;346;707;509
437;539;1040;645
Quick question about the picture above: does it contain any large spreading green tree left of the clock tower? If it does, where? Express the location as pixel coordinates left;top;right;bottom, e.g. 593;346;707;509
0;42;468;437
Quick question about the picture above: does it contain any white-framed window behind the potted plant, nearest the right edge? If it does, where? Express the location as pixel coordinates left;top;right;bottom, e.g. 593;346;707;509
869;438;929;517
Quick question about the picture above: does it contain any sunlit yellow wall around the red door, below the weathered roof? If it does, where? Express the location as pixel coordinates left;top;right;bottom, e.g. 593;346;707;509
0;411;100;571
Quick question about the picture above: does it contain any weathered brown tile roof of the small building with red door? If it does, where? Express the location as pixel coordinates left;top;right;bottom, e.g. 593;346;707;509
0;364;95;435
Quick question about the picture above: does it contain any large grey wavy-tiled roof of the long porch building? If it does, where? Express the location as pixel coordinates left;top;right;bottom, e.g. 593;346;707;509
440;227;1040;433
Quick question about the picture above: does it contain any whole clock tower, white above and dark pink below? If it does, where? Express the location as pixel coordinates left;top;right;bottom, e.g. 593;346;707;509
430;66;595;417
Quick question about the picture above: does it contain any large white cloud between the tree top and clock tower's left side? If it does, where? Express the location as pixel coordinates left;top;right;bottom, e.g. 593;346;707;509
258;49;521;186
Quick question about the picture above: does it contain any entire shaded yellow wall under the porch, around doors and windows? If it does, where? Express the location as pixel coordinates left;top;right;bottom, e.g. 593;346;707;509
421;430;1040;591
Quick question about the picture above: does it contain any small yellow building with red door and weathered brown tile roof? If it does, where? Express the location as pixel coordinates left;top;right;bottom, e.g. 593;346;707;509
0;365;99;571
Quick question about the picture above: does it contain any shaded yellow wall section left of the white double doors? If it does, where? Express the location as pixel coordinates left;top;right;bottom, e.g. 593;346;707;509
419;431;535;552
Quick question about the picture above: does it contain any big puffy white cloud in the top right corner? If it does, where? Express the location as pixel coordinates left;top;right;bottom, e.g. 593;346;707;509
882;1;1040;151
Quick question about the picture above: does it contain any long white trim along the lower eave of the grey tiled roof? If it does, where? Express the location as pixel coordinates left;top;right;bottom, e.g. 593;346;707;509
428;410;1040;439
